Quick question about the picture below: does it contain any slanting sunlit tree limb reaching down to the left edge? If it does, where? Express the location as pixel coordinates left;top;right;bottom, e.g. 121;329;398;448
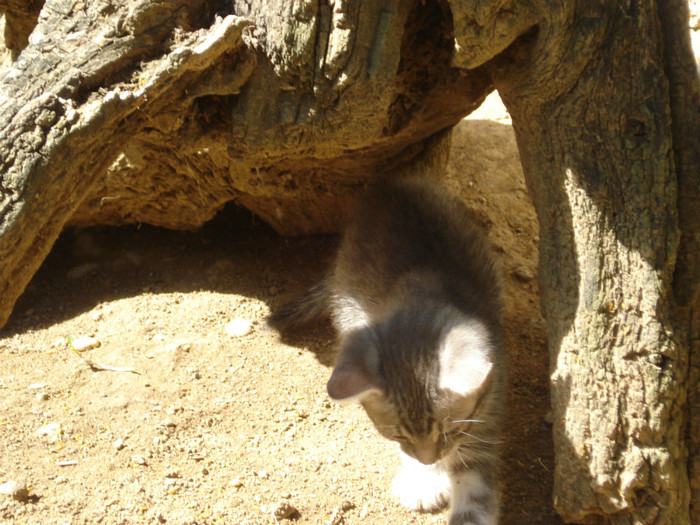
0;2;250;332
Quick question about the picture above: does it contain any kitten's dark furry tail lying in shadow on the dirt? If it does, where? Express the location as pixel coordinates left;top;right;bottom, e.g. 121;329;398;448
265;278;329;332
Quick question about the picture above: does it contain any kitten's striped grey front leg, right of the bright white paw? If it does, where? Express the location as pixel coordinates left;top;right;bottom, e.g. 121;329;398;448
448;470;498;525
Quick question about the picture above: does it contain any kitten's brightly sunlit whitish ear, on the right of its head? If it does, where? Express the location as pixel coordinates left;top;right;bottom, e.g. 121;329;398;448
439;321;493;396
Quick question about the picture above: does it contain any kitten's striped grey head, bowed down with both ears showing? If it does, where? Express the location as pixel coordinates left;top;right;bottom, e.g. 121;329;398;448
328;305;494;464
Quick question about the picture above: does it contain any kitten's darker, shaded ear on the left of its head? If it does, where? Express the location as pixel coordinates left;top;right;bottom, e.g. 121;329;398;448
326;328;381;402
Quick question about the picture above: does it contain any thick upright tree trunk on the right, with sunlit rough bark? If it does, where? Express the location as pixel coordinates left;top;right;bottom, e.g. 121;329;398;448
494;1;700;524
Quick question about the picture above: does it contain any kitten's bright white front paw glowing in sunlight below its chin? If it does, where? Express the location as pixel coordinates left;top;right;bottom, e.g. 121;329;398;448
391;453;450;512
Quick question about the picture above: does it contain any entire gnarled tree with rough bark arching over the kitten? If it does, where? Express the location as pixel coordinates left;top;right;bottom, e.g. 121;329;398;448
0;0;700;524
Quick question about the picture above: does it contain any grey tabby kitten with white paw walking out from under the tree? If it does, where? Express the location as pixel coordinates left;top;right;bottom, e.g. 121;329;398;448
268;177;505;525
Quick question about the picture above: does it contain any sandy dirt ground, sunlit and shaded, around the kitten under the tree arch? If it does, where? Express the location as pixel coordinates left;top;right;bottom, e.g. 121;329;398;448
0;94;561;525
